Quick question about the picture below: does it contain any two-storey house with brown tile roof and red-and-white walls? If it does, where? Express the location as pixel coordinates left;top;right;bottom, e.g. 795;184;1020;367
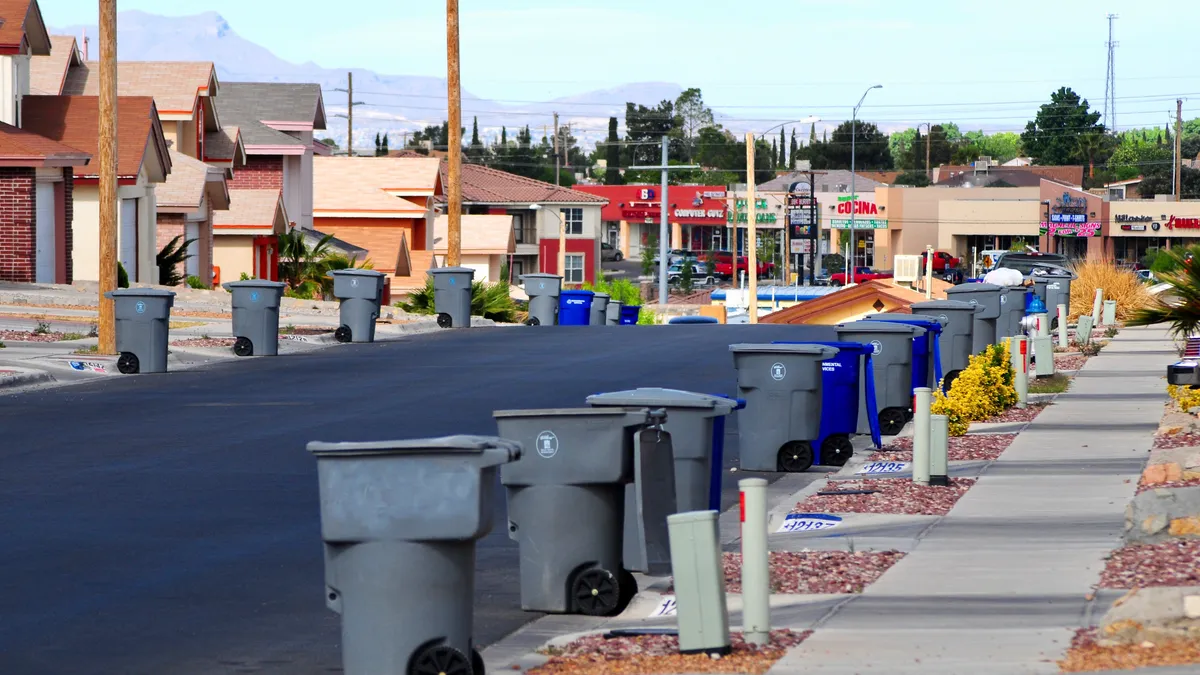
442;162;608;283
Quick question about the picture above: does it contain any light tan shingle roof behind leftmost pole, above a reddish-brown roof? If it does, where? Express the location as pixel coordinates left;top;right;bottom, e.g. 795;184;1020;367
62;61;223;115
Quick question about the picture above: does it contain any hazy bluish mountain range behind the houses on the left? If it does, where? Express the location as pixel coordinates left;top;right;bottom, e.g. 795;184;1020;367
50;11;683;148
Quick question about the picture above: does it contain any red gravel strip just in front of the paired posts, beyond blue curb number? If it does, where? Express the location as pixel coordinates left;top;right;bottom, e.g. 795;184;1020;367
792;478;976;515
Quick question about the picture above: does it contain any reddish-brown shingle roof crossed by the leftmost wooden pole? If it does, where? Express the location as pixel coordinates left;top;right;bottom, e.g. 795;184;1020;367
22;96;170;183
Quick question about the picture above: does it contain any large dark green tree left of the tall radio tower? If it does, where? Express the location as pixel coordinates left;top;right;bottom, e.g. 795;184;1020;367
1021;86;1105;166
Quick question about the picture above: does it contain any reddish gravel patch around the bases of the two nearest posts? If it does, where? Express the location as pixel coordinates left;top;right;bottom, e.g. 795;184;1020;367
527;628;812;675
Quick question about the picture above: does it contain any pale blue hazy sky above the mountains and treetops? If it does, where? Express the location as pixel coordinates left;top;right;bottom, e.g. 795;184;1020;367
42;0;1200;131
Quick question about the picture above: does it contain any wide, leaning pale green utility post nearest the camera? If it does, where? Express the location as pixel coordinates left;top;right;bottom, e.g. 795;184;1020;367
667;510;731;656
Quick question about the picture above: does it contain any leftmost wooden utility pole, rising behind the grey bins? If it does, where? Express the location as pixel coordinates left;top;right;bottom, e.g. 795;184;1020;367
96;0;116;354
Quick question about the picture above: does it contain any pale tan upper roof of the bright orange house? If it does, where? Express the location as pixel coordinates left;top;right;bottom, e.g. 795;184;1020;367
312;156;440;216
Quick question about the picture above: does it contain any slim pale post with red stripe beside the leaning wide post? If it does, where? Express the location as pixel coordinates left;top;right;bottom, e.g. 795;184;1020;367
738;478;770;645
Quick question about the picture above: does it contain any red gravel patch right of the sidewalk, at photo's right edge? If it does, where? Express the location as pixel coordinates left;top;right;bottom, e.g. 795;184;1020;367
1100;539;1200;589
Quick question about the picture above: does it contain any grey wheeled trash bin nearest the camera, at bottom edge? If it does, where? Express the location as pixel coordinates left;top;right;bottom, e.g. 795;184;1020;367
308;436;521;675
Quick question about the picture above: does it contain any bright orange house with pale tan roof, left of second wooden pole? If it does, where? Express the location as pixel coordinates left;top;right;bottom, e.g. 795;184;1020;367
313;156;443;291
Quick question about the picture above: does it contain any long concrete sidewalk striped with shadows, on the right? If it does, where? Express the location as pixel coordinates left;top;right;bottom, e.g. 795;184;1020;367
770;329;1177;675
